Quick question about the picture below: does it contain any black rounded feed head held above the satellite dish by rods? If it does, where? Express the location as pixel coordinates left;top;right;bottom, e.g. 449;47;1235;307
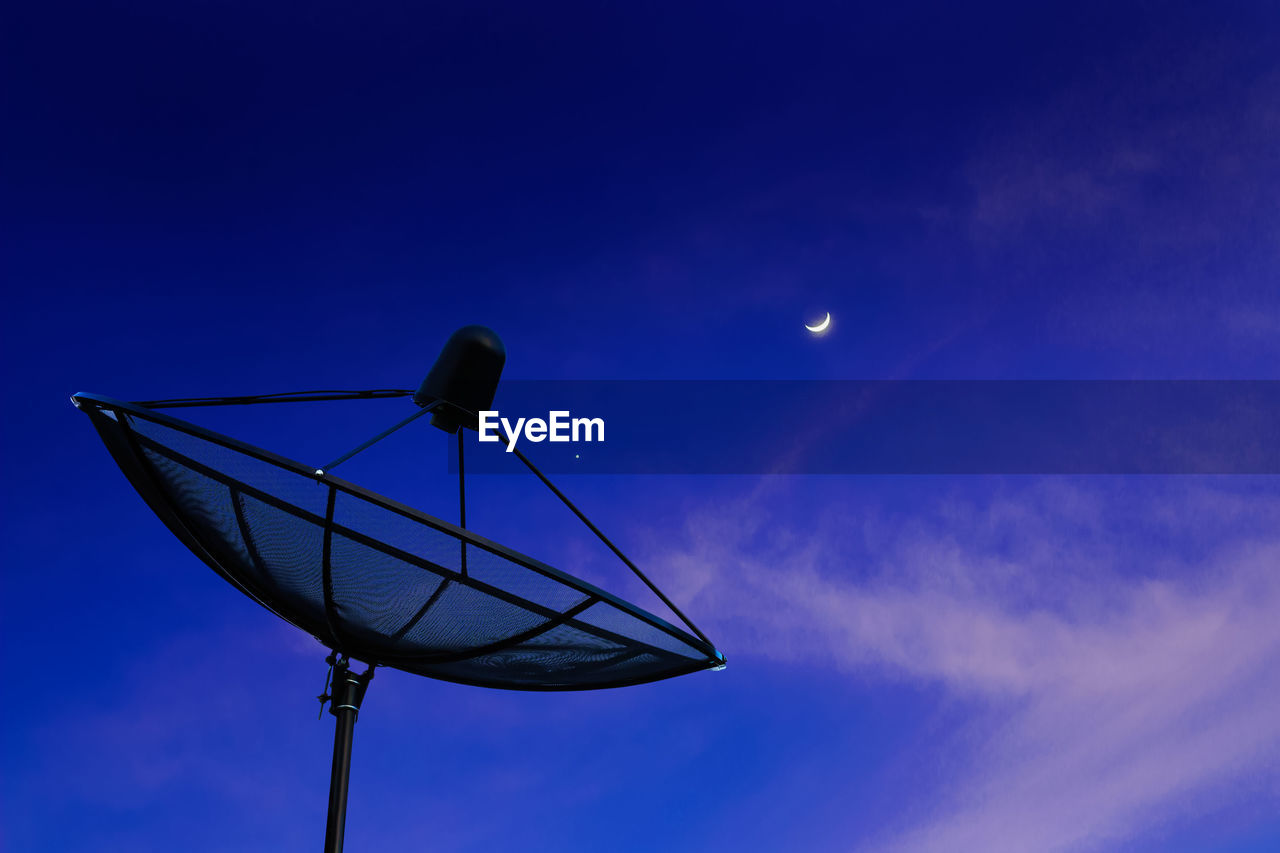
413;325;507;433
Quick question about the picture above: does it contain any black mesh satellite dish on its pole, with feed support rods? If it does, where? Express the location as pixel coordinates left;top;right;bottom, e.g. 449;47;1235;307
72;325;724;850
